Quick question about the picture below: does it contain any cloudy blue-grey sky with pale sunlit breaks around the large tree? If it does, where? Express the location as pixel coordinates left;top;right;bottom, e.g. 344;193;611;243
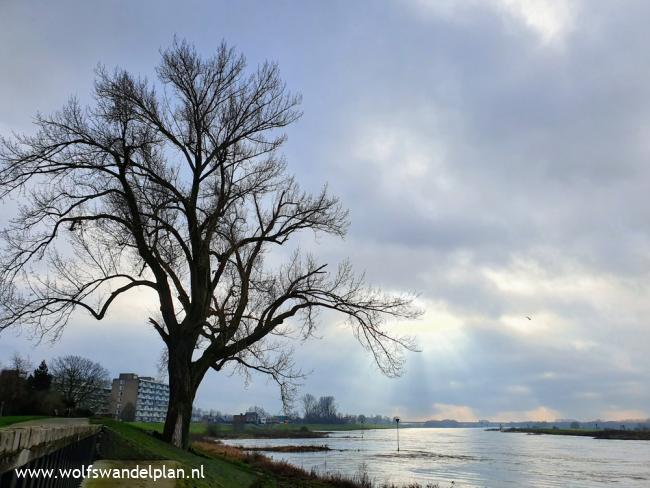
0;0;650;420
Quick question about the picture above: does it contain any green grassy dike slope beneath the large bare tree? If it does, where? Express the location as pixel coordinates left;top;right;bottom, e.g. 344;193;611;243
1;416;442;488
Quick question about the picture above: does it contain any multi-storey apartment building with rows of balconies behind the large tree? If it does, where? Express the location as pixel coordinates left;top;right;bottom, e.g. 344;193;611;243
111;373;169;422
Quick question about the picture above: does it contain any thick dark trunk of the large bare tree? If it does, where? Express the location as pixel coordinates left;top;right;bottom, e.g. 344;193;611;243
163;349;196;449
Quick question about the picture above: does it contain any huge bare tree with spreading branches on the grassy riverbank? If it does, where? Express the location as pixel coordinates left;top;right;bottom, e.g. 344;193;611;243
0;41;416;447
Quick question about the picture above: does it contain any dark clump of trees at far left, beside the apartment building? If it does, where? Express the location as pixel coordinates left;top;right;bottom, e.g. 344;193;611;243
0;354;110;415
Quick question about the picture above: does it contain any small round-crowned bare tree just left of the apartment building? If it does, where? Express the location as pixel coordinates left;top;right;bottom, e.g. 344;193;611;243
51;355;109;411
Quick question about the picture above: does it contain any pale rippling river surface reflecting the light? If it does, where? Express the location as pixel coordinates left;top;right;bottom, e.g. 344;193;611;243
226;428;650;488
